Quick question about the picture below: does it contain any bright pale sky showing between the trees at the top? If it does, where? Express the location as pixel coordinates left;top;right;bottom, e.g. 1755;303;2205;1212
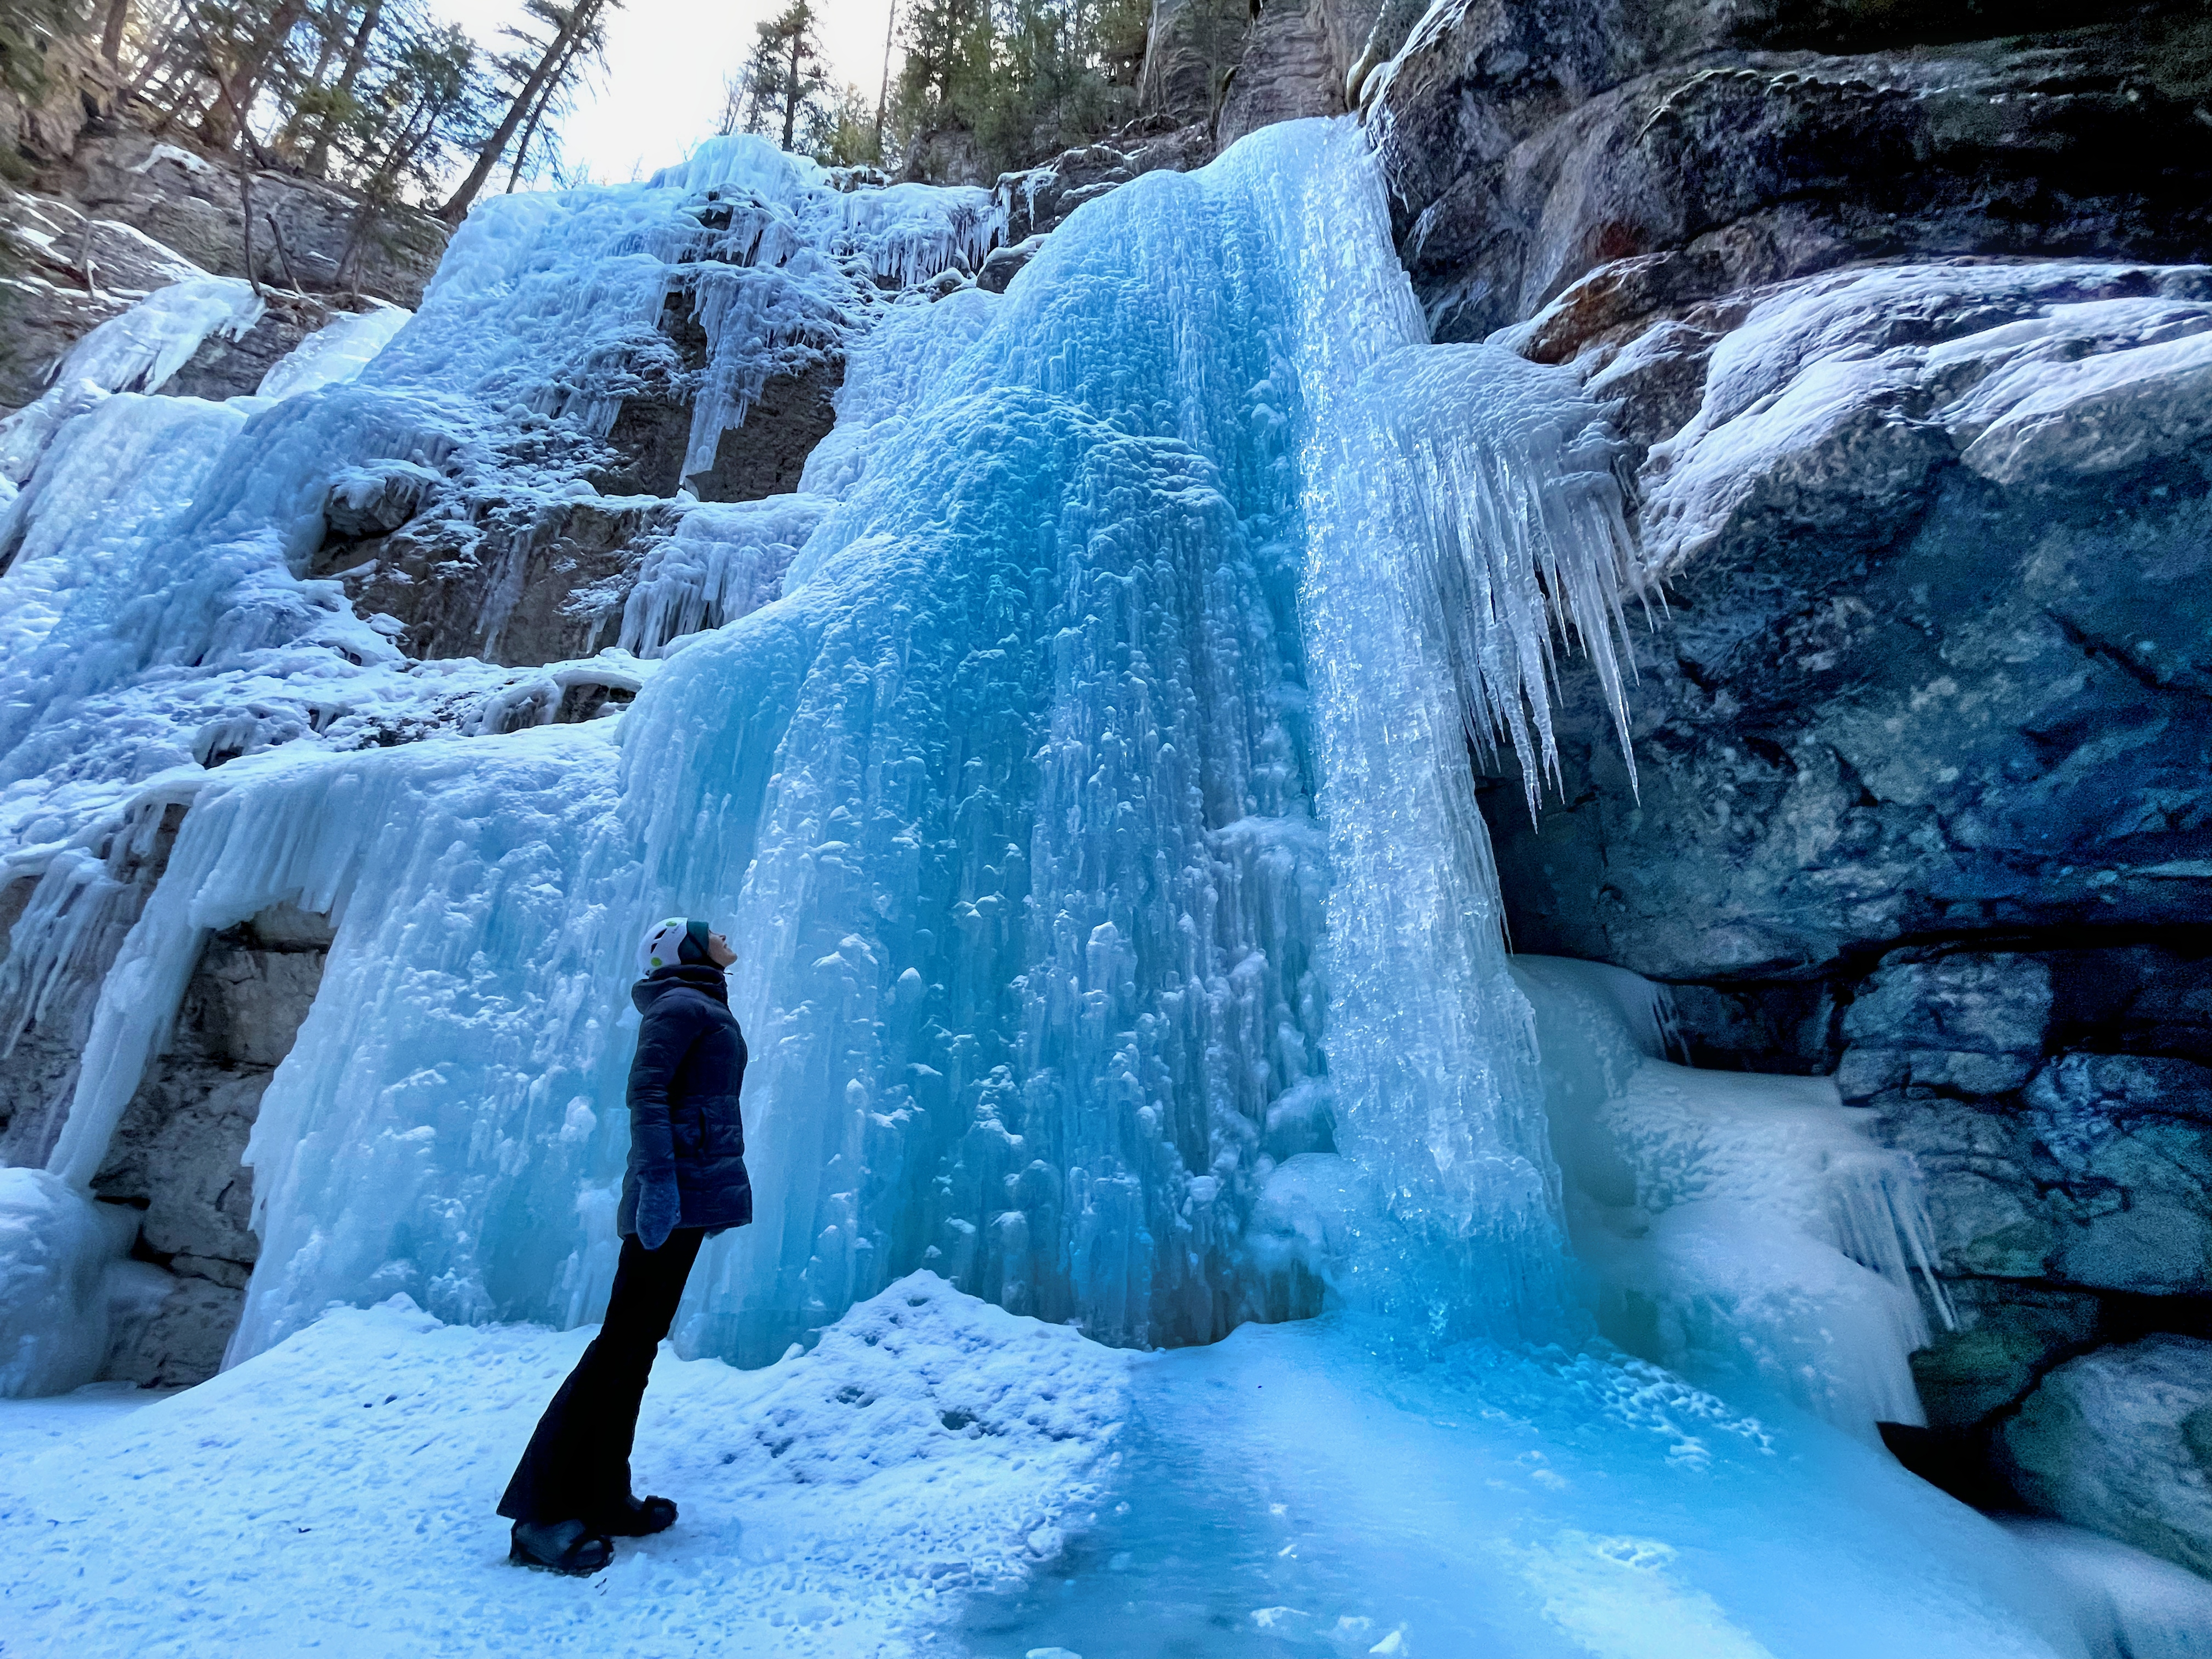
431;0;889;184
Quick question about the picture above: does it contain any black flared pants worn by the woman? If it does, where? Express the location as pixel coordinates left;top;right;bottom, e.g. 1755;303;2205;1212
500;1228;706;1524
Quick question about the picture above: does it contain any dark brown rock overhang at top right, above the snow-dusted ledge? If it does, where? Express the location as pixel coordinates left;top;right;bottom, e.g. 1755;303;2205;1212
1369;0;2212;340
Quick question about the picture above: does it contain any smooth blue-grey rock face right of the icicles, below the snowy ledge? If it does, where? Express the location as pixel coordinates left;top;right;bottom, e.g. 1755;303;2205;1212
1493;444;2212;982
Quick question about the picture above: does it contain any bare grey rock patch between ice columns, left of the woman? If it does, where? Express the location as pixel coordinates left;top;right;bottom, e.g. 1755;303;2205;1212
93;907;332;1387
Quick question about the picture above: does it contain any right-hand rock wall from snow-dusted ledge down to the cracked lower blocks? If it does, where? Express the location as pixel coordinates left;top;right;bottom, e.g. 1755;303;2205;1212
1484;273;2212;1495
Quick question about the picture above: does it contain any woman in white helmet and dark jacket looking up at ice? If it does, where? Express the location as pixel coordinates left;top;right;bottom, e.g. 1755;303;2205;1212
500;916;752;1573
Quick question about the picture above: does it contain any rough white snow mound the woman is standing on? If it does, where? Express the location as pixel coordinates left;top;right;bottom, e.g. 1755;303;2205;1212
0;1272;1130;1659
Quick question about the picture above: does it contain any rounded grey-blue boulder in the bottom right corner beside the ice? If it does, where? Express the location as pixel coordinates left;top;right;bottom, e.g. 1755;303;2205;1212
2002;1336;2212;1575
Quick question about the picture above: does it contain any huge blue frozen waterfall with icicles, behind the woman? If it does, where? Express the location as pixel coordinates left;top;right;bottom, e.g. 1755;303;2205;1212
0;124;1663;1361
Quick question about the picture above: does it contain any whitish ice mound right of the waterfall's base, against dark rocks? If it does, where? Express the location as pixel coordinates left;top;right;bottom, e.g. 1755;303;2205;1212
1513;956;1951;1435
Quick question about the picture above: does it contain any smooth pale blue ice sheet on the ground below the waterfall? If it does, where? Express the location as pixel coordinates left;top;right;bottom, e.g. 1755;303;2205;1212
964;1314;2086;1659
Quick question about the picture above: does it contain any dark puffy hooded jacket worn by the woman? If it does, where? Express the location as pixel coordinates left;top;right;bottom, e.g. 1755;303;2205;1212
615;962;752;1234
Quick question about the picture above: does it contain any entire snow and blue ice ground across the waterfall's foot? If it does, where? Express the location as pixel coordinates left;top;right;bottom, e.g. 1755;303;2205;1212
0;1274;2141;1659
